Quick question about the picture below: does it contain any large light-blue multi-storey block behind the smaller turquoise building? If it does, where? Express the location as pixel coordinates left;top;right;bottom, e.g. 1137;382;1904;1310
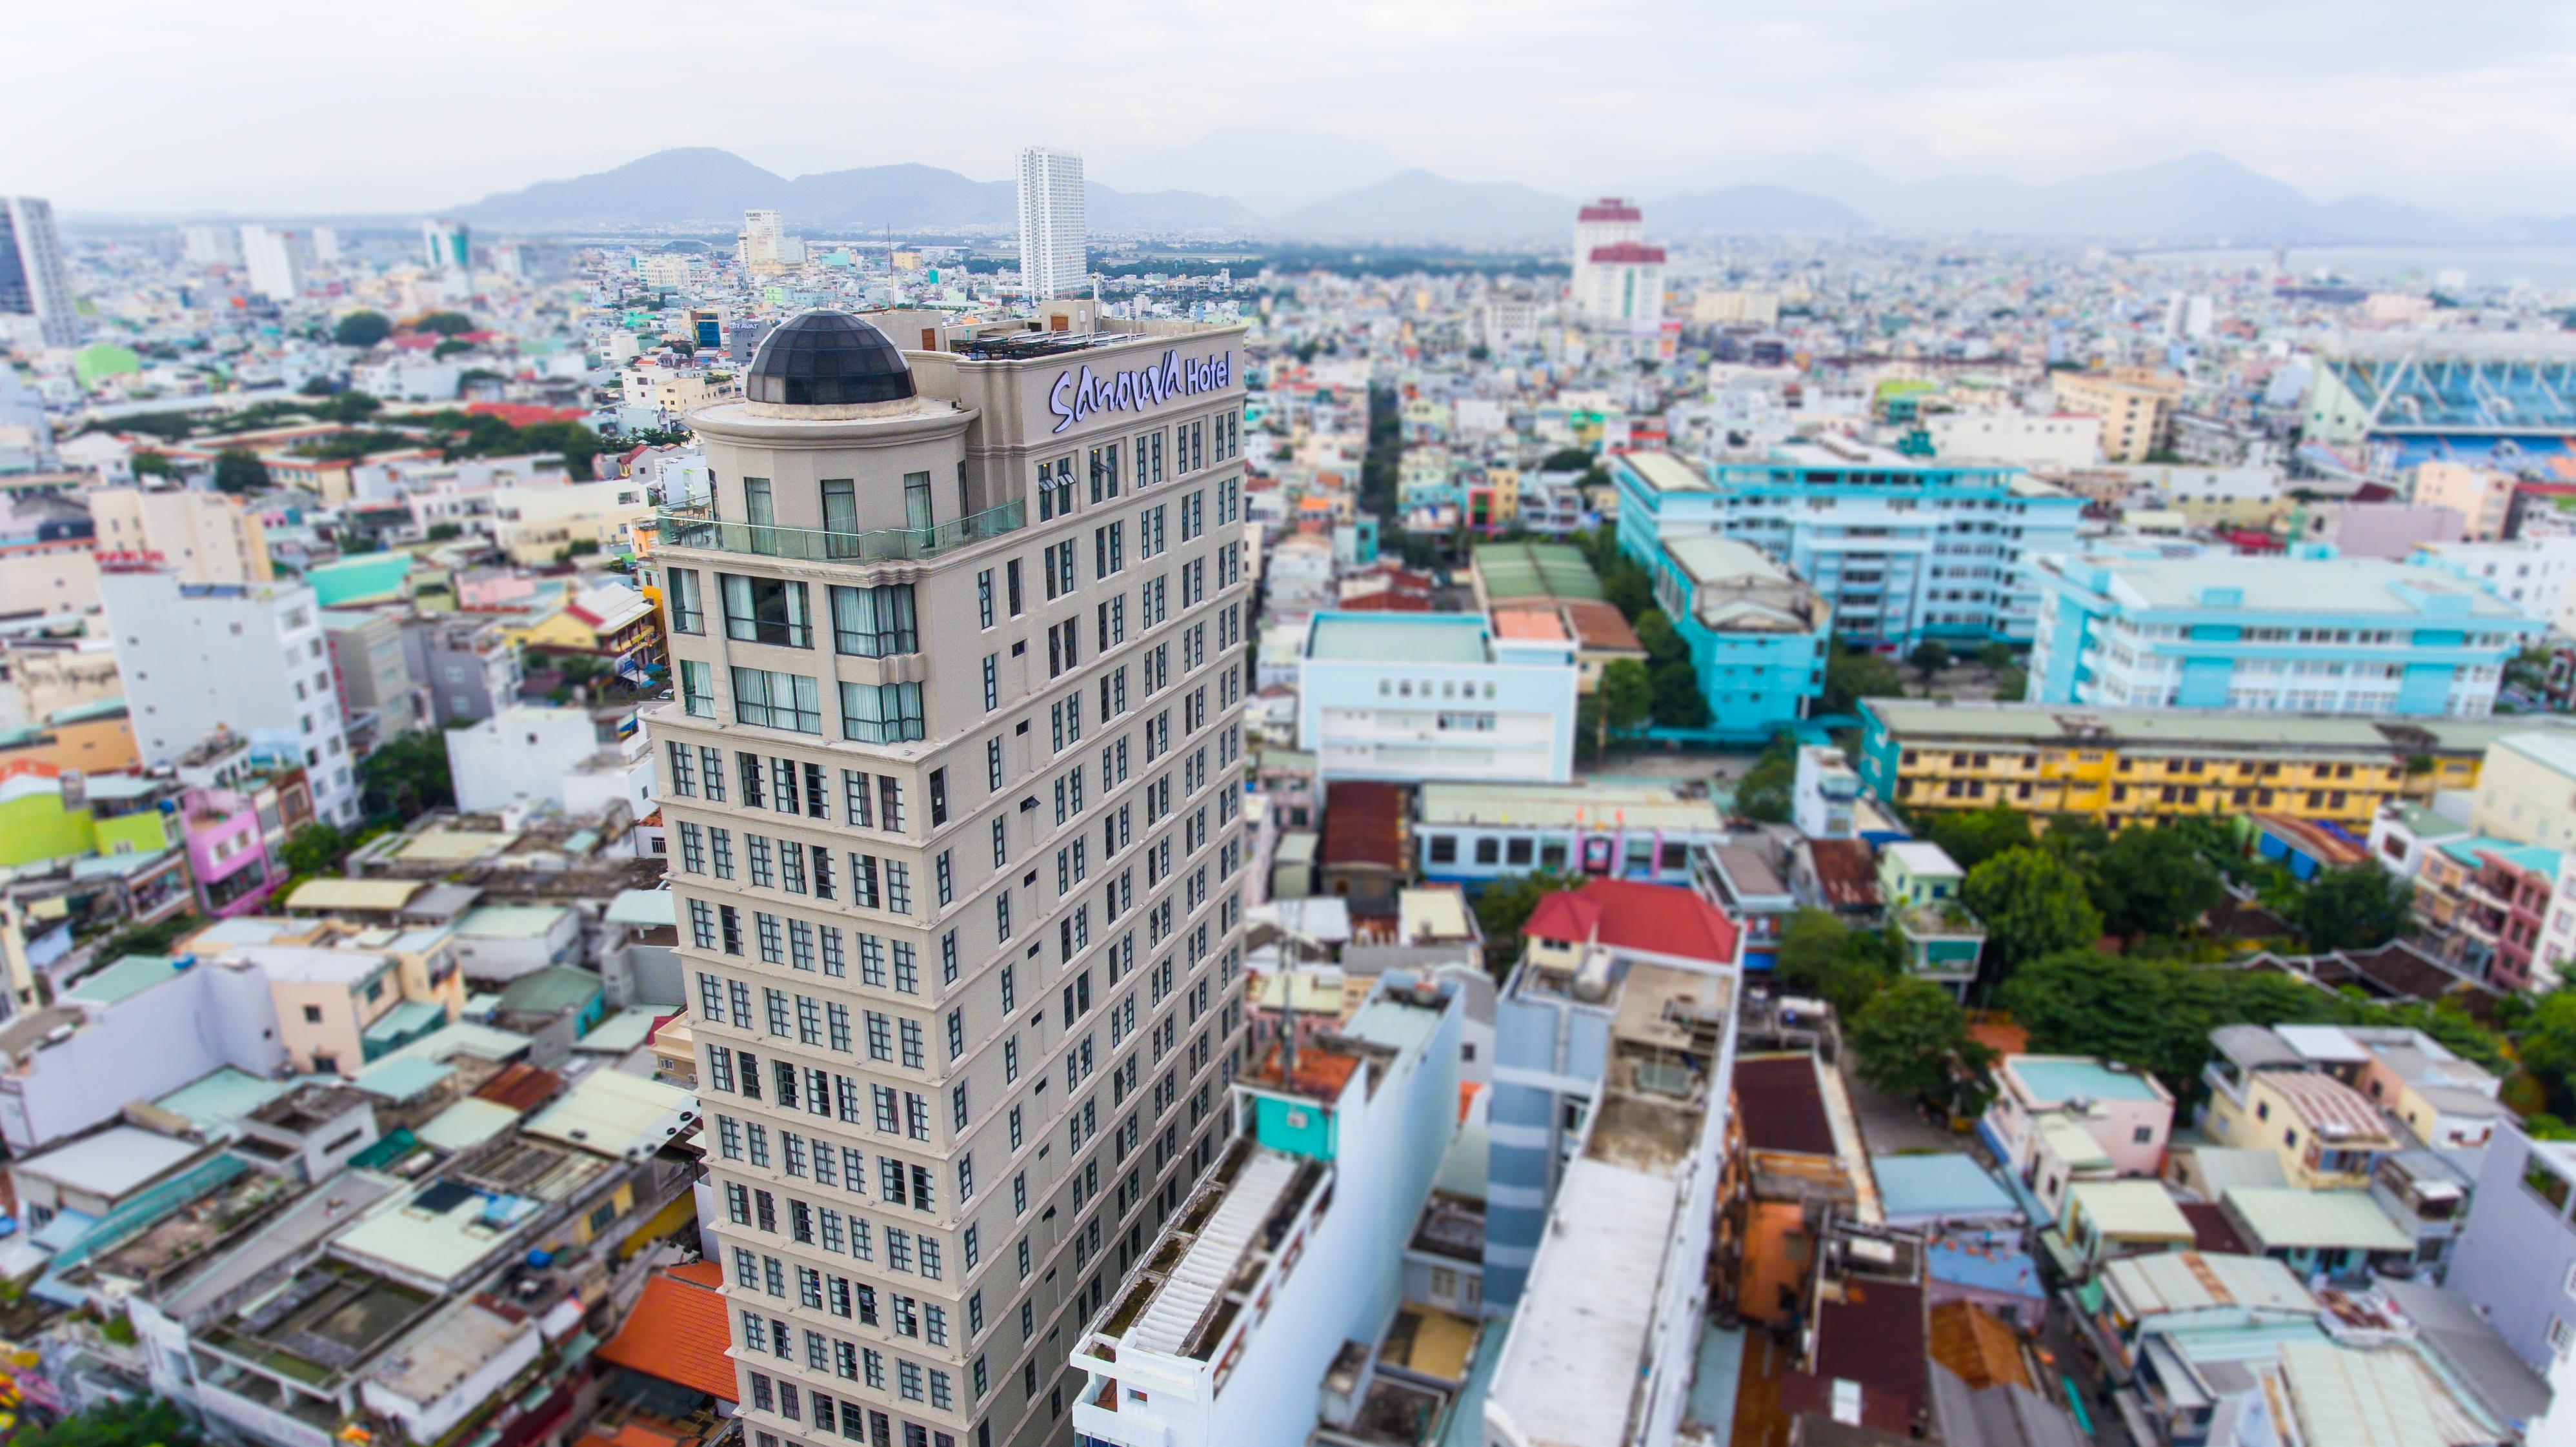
1610;438;2084;643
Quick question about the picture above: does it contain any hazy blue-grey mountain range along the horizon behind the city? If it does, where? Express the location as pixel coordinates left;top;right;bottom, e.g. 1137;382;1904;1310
448;143;2576;245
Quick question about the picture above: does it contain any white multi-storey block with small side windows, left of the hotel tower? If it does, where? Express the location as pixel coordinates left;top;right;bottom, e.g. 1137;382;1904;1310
98;569;358;824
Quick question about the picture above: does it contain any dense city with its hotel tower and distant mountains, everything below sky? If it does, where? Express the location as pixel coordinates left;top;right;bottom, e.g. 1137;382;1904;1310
0;67;2576;1447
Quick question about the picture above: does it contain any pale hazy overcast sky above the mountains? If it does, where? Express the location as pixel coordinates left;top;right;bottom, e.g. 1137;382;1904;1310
20;0;2576;214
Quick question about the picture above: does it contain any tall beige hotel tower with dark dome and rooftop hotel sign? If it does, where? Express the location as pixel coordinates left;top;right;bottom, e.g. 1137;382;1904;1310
647;312;1249;1447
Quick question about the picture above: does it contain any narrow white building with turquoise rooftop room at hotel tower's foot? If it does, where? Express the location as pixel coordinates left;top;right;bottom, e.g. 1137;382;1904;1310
1072;973;1463;1447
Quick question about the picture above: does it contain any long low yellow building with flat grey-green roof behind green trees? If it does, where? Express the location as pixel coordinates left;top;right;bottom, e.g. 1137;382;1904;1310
1860;698;2535;835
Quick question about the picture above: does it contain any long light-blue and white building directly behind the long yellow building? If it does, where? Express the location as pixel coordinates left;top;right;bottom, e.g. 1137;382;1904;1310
2028;554;2548;718
